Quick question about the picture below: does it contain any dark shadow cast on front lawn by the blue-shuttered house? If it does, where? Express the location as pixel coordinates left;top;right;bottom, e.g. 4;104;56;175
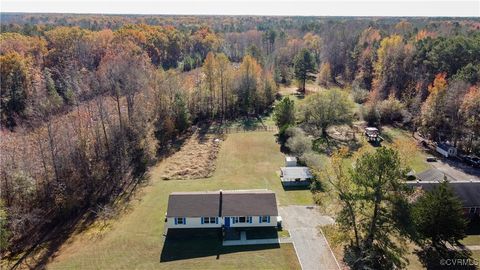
160;229;280;263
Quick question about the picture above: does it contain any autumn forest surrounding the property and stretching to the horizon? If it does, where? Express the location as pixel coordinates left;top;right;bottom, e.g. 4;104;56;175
0;13;480;262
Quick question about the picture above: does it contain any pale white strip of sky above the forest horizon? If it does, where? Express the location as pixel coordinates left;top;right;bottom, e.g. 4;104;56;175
0;0;480;17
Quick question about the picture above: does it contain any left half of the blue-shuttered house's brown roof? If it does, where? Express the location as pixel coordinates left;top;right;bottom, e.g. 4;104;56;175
167;192;220;217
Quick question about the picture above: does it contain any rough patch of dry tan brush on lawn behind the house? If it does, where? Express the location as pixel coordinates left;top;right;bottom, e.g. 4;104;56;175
160;132;223;180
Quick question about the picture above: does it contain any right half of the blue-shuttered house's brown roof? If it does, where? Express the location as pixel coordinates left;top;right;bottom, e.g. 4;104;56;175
222;190;278;216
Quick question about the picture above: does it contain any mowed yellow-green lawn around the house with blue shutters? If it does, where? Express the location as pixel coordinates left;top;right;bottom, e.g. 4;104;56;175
47;132;313;269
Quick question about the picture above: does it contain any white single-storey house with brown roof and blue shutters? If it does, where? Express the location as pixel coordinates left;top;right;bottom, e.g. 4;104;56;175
166;190;278;229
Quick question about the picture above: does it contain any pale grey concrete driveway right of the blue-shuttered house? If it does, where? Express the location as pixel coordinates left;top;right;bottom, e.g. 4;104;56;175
279;205;339;270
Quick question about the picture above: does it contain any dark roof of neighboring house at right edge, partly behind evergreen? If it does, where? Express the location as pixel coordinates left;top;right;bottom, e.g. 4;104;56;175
407;181;480;207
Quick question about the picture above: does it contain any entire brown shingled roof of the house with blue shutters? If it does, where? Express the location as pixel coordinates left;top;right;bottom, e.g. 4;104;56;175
167;190;278;217
